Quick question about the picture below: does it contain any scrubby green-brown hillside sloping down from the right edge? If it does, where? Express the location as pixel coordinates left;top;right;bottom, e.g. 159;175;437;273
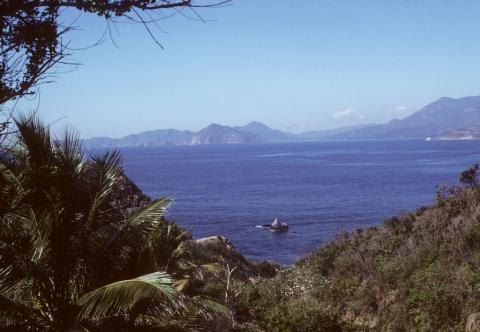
237;176;480;331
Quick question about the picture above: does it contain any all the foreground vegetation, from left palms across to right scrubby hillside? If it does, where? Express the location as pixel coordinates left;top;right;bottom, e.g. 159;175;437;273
0;117;480;331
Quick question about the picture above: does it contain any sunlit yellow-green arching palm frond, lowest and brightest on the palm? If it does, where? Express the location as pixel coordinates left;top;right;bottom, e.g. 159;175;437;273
78;272;184;320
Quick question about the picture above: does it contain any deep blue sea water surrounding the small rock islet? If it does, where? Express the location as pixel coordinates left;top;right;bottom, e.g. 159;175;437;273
115;140;480;264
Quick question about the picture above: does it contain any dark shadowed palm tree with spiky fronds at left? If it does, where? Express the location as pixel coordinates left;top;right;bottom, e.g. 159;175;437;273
0;116;187;331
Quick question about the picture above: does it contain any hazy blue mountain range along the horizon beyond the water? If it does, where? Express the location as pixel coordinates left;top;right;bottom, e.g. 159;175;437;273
84;96;480;149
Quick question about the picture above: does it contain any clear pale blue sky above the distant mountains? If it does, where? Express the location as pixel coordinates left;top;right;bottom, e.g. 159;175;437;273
19;0;480;137
